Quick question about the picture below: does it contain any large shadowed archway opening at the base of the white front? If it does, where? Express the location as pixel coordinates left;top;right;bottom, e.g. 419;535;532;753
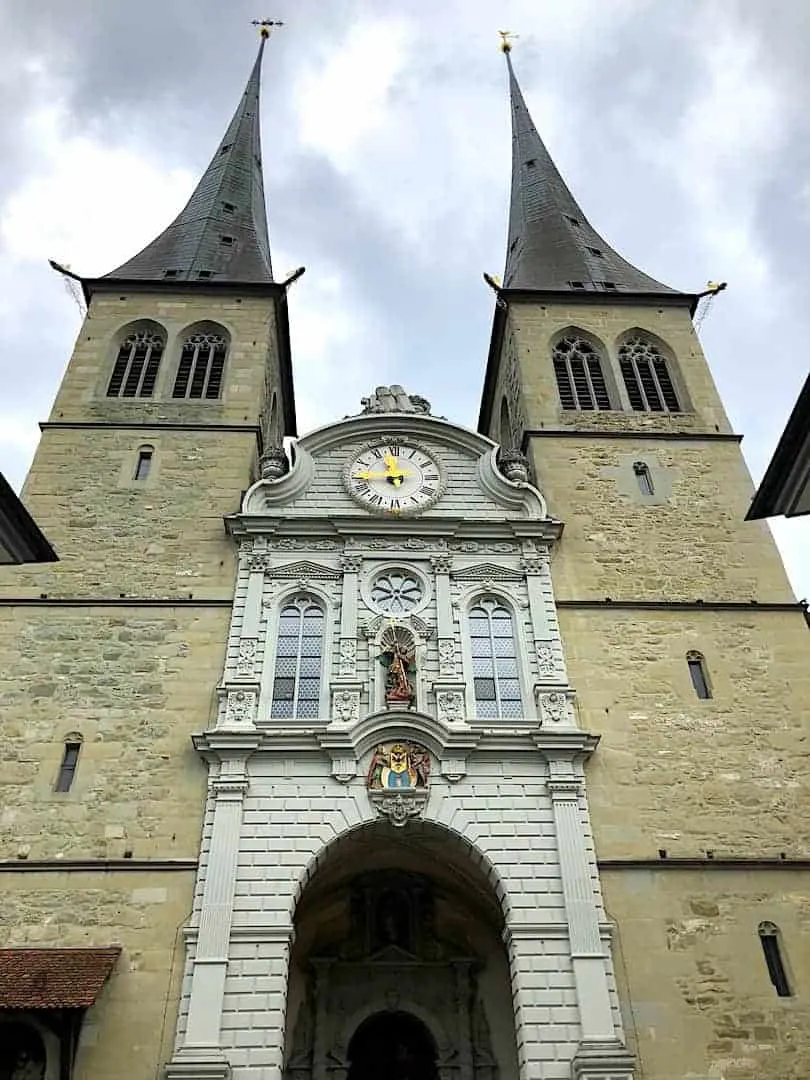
285;822;517;1080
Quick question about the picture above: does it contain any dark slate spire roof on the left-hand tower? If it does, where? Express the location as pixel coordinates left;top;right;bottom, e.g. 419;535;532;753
106;36;273;282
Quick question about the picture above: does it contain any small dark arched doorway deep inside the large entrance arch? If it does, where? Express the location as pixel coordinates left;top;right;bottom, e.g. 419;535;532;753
347;1012;437;1080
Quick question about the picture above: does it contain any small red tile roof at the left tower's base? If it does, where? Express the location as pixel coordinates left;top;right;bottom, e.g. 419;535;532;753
0;946;121;1009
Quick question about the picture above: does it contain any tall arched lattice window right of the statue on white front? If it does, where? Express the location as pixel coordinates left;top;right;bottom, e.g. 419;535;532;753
469;596;523;719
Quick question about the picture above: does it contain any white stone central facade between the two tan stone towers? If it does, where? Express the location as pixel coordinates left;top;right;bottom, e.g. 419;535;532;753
167;406;632;1080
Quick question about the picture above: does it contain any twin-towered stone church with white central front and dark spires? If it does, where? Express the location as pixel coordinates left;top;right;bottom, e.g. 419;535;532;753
0;25;810;1080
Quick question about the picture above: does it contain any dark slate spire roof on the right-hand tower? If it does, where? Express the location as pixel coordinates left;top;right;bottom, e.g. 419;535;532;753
503;44;676;294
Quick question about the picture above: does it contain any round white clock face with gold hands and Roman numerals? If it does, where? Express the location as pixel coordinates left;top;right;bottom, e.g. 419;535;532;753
345;438;444;517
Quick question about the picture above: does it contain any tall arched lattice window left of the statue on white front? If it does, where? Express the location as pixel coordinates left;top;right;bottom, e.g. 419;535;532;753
270;596;325;719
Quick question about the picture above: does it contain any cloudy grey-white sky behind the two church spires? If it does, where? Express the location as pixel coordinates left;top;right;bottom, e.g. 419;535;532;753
0;0;810;597
